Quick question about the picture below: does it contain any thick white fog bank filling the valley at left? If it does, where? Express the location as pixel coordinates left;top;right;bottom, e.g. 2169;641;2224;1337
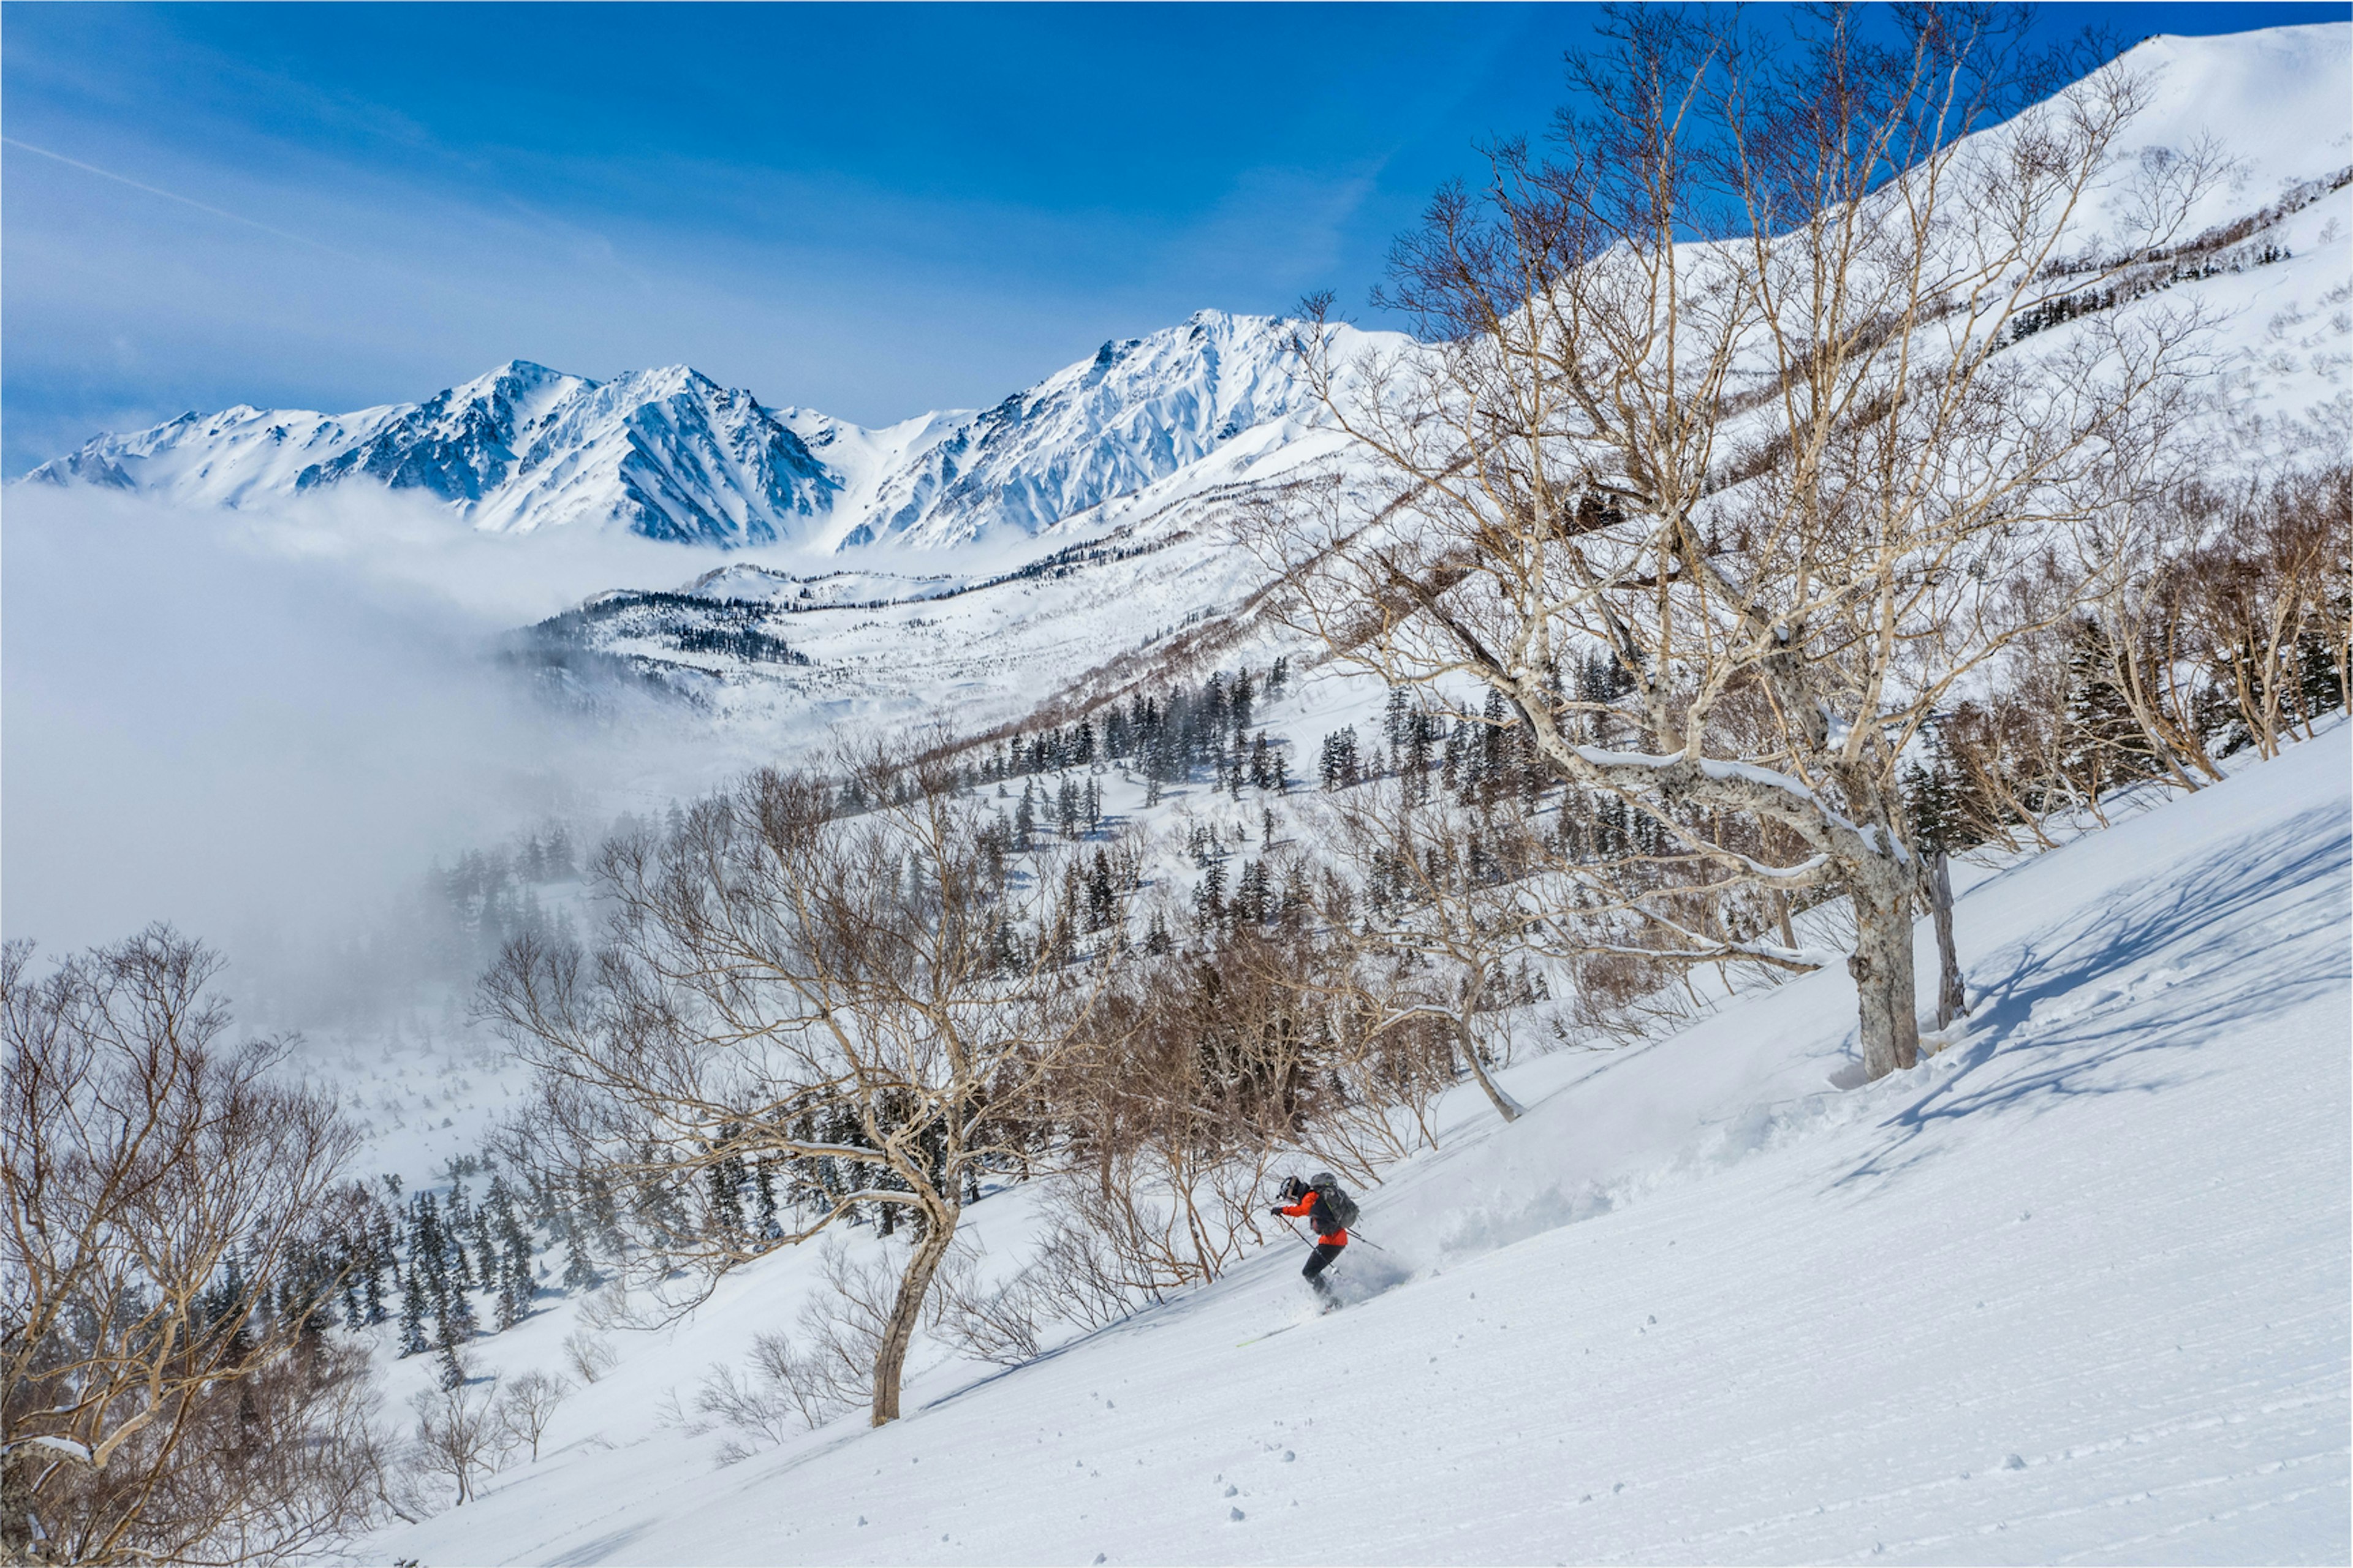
0;485;757;988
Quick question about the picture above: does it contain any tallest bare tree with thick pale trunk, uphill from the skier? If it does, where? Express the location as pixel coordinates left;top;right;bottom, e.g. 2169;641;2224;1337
1247;7;2216;1076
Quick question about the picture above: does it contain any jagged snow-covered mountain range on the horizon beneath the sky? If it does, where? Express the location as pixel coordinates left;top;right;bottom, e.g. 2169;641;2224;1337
26;311;1374;551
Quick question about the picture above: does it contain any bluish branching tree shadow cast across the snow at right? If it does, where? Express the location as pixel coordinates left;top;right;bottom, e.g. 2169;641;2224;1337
1833;808;2353;1187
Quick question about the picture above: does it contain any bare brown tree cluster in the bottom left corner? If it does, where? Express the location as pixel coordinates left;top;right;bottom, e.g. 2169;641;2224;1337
0;925;381;1563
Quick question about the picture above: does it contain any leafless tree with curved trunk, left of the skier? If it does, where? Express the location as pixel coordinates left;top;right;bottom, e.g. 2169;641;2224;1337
482;756;1120;1425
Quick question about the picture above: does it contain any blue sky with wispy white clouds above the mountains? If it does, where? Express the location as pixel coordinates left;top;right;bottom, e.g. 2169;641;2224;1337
0;2;2353;473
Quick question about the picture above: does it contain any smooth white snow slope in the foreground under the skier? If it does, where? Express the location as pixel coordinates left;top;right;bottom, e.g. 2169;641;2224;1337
362;725;2353;1563
